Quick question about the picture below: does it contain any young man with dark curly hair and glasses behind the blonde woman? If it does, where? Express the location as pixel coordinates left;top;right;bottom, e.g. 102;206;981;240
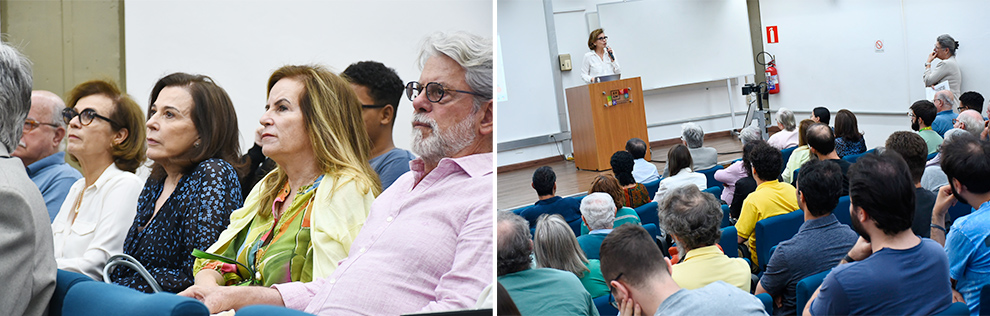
341;61;416;191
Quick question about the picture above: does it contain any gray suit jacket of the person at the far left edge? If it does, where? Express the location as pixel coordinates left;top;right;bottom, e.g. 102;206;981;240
0;145;56;316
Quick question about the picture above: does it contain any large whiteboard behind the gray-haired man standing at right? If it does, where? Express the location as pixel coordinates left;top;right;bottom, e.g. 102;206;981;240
760;0;990;113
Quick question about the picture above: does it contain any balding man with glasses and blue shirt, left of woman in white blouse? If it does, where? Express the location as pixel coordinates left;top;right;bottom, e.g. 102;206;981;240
11;90;82;222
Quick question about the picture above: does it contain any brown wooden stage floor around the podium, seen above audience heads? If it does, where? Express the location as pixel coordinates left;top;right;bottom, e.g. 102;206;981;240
504;136;742;210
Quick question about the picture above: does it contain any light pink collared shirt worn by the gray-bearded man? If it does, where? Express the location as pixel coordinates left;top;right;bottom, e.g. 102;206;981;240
273;153;494;315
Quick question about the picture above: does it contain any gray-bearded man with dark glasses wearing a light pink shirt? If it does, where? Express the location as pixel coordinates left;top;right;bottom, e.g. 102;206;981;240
180;33;494;315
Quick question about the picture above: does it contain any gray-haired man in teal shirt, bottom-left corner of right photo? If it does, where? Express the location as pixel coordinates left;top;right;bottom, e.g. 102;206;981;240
496;211;596;315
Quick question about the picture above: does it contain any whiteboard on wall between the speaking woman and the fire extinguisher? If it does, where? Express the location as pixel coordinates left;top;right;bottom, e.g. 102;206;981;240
600;0;753;90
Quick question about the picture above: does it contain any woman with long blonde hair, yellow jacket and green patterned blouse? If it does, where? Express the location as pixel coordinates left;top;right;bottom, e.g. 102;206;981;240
180;66;381;298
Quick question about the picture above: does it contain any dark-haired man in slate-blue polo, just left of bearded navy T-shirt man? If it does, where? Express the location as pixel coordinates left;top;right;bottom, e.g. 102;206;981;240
756;160;858;315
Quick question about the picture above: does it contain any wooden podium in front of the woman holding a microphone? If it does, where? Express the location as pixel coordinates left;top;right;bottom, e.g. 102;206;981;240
566;77;650;171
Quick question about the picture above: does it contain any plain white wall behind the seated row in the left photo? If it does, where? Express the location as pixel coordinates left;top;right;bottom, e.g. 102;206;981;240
124;0;494;156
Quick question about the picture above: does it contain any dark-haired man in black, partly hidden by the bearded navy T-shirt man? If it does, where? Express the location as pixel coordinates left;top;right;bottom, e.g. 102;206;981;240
884;131;935;238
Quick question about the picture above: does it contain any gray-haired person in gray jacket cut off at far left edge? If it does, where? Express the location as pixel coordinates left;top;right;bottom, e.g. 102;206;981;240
0;42;56;316
